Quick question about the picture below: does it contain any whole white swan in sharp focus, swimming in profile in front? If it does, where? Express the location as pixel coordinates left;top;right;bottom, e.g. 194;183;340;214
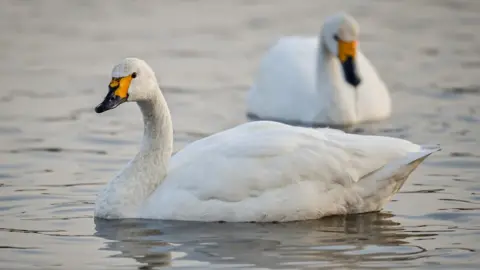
94;58;439;222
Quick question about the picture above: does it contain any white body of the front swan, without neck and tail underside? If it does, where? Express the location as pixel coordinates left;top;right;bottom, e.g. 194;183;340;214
139;121;432;221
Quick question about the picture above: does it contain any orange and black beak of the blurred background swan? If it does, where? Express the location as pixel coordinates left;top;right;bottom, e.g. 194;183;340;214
338;39;361;88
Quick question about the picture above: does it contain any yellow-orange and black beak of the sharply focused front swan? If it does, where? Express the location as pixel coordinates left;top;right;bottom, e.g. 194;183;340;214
95;76;132;113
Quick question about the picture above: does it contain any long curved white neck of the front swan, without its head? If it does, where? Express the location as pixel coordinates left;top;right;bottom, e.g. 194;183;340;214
95;81;173;218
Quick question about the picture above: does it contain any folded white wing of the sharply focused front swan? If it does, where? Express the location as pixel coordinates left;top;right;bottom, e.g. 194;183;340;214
165;121;420;202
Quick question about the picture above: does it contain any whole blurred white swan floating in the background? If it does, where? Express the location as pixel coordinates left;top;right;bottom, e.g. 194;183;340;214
247;13;391;127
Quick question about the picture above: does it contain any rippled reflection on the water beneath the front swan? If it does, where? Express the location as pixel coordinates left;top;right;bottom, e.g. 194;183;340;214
95;213;436;269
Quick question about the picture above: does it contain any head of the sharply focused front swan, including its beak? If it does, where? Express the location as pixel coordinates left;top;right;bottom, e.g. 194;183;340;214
95;58;158;113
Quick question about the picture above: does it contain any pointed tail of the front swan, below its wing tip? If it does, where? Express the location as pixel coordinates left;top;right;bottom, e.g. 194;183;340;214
352;145;441;213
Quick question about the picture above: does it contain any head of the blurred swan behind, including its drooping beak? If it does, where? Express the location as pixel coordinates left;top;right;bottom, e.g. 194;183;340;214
321;13;361;87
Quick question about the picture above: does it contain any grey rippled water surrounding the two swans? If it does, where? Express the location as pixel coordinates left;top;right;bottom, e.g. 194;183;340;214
0;0;480;269
